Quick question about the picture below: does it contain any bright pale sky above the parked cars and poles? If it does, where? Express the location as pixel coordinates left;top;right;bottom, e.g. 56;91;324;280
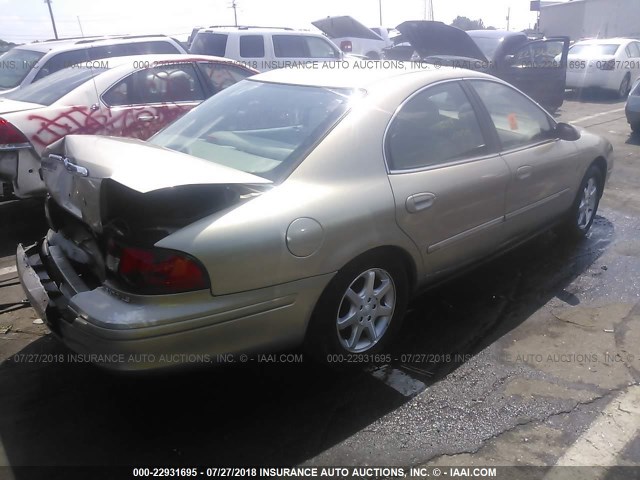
0;0;552;43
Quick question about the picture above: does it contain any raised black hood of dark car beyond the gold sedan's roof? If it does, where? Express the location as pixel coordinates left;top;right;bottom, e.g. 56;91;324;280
396;20;487;62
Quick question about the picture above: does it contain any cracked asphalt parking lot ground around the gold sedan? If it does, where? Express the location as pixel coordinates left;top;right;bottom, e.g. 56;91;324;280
0;94;640;478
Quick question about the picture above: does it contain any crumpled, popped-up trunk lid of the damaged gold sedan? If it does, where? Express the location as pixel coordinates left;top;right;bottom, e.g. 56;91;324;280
42;135;272;235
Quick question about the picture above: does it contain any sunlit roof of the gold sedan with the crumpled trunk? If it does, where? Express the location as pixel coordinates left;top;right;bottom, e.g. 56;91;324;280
251;60;495;90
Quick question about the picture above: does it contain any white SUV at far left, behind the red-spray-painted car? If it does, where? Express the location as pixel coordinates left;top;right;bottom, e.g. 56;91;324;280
0;35;187;95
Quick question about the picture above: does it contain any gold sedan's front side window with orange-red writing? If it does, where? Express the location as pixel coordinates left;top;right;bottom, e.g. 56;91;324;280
470;80;552;149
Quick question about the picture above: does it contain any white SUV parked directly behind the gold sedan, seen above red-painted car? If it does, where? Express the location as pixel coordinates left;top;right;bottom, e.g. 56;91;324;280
189;26;343;71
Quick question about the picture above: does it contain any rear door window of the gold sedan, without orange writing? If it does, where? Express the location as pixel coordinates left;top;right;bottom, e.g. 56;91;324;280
386;82;487;170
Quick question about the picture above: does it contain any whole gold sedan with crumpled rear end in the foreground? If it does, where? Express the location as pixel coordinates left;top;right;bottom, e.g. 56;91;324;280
17;64;613;370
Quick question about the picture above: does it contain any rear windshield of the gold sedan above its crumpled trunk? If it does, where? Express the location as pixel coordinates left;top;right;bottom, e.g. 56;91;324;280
150;80;353;182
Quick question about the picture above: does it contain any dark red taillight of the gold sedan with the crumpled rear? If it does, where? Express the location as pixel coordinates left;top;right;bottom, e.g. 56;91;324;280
107;247;209;295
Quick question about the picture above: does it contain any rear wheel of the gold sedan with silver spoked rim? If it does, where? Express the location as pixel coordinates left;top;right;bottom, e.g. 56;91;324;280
305;252;409;362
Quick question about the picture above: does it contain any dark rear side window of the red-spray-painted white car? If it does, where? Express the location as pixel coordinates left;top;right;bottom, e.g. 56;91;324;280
102;64;205;106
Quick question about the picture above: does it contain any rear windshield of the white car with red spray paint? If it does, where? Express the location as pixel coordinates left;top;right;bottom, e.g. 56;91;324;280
4;67;107;105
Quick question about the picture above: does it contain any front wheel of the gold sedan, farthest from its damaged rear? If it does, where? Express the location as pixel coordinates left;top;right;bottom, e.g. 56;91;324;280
564;165;604;240
